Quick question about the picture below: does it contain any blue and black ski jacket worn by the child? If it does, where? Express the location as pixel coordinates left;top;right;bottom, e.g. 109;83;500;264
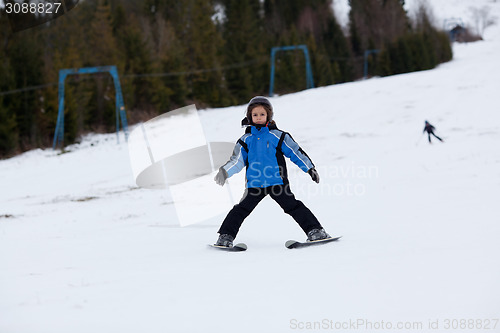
222;123;314;188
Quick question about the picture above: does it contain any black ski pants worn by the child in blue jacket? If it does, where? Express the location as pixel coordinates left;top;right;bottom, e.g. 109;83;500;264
218;184;322;237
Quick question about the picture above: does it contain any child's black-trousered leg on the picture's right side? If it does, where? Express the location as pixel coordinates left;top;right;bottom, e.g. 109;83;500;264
269;185;322;234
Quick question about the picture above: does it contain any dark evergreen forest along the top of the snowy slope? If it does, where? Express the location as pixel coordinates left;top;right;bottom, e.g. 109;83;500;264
0;0;452;158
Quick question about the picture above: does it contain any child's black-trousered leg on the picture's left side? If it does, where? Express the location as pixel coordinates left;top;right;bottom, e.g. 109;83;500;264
218;188;267;238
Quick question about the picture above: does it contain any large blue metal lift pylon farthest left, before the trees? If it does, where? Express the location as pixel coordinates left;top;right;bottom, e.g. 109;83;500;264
52;66;128;149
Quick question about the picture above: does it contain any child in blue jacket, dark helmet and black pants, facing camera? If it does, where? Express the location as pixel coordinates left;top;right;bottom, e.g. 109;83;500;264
214;96;330;247
